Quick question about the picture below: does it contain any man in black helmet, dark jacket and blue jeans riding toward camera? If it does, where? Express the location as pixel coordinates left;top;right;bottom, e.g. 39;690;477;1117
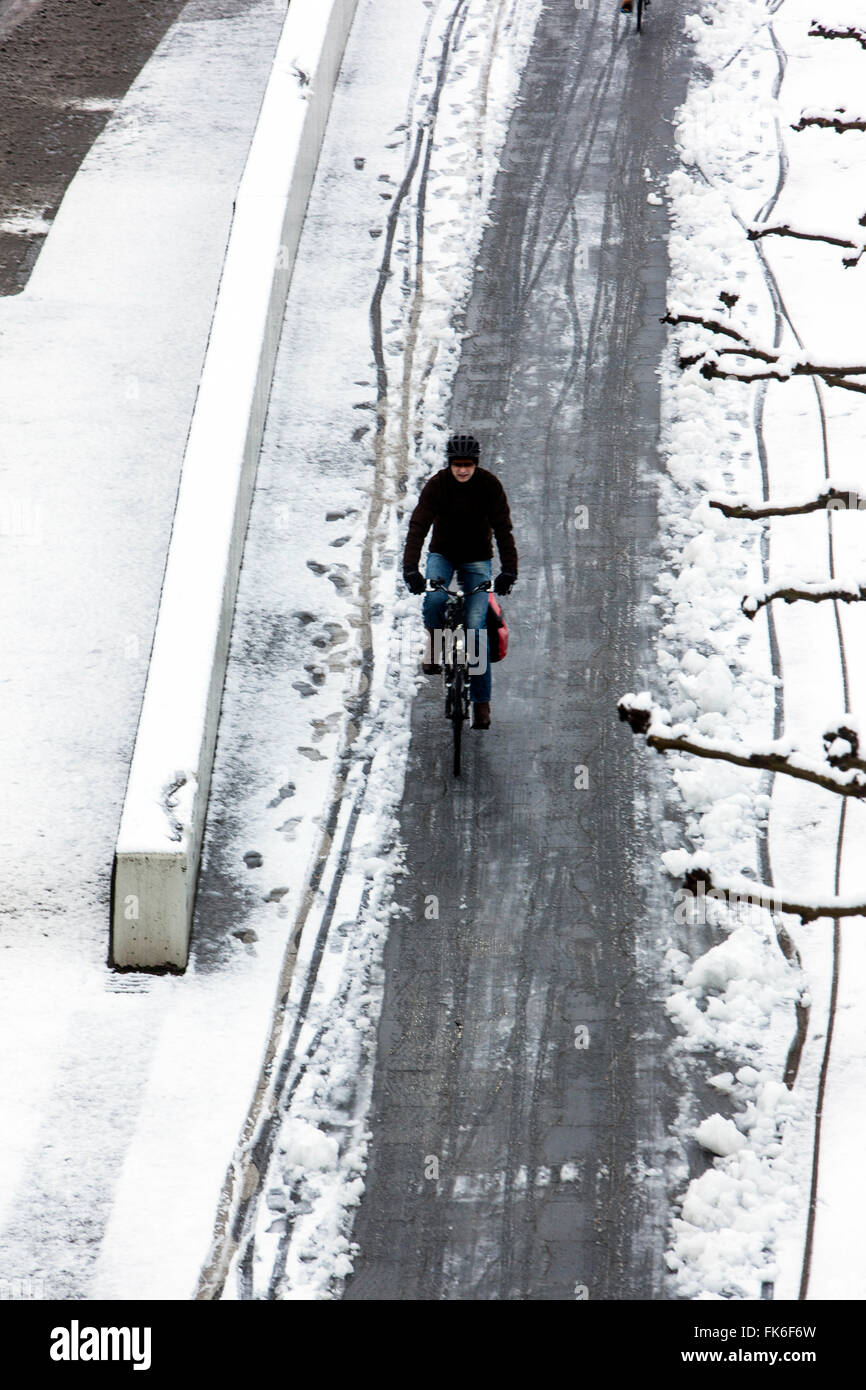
403;434;517;728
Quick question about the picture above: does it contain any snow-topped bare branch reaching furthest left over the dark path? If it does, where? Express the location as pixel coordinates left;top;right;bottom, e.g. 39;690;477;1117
617;691;866;796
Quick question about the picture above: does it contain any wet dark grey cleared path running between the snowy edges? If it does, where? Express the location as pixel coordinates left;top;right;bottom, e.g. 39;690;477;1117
345;0;688;1300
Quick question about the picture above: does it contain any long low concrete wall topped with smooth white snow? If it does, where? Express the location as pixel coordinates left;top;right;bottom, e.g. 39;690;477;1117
110;0;357;970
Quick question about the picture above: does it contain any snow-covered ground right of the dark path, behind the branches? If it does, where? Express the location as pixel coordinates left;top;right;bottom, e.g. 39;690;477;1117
659;0;866;1298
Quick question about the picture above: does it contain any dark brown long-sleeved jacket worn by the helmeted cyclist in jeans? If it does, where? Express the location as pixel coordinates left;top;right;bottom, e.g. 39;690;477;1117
403;468;517;574
